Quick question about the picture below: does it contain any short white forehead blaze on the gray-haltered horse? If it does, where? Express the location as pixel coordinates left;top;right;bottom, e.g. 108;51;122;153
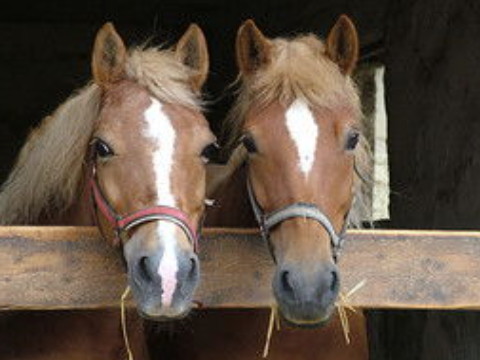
285;100;319;177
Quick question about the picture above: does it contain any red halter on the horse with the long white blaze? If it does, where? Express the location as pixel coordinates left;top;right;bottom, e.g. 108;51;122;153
89;165;198;252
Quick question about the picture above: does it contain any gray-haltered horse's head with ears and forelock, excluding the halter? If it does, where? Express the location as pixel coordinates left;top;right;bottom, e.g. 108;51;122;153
237;16;359;326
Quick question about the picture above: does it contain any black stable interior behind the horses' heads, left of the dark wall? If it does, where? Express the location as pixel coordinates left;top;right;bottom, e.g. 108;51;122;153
0;0;386;179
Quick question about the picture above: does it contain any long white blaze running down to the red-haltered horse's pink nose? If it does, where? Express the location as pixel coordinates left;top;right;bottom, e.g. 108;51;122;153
145;98;178;307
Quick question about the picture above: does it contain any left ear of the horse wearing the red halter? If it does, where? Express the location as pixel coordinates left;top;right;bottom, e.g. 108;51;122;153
92;22;127;87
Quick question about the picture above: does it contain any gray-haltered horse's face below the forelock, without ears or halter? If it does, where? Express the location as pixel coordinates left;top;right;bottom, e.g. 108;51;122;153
244;100;358;324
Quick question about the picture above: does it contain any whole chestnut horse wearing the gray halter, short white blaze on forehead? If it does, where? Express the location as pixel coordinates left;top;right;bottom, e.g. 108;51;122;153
178;16;369;360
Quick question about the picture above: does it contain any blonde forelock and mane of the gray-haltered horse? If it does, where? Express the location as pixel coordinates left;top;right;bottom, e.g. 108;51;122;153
223;34;372;227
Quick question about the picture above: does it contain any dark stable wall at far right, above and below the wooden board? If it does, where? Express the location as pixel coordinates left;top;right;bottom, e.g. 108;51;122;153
369;0;480;360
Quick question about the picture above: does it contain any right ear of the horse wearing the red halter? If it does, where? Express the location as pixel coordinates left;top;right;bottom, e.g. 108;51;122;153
175;24;209;91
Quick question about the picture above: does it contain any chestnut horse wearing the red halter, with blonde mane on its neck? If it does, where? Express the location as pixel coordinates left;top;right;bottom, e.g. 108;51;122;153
0;23;215;360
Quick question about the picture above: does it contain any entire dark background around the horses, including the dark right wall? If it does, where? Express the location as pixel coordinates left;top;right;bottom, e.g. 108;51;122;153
0;0;480;360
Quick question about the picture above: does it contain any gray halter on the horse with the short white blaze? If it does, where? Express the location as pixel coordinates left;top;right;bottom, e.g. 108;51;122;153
247;176;348;260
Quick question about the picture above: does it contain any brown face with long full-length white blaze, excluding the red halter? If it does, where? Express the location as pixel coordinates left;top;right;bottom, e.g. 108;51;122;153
92;23;215;320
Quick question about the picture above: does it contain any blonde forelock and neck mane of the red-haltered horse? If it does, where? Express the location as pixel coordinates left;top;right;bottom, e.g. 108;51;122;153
0;48;201;225
